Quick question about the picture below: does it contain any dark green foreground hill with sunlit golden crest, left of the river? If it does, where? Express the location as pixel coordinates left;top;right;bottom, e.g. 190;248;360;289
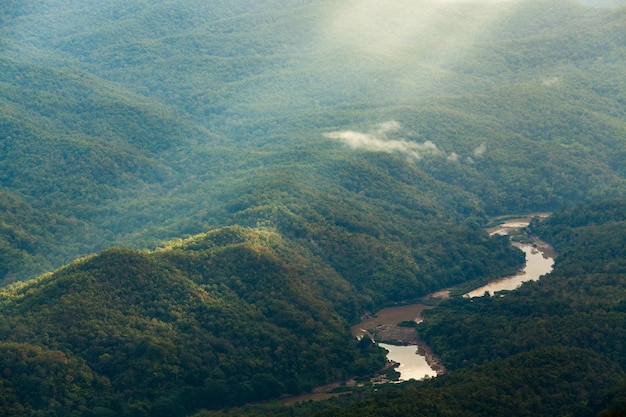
0;227;384;416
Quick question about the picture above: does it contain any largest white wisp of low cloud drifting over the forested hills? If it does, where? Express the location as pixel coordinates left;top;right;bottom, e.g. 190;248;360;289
324;120;442;160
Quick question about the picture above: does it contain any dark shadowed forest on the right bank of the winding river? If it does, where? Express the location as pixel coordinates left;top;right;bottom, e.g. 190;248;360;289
264;199;626;416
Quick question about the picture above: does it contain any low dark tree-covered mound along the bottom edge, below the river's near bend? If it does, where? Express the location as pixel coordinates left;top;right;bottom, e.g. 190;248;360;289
315;347;620;416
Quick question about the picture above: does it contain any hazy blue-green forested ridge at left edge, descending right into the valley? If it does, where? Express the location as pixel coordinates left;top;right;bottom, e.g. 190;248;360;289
0;54;206;205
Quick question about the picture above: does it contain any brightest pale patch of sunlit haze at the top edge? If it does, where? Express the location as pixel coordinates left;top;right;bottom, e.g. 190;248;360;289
320;0;511;66
